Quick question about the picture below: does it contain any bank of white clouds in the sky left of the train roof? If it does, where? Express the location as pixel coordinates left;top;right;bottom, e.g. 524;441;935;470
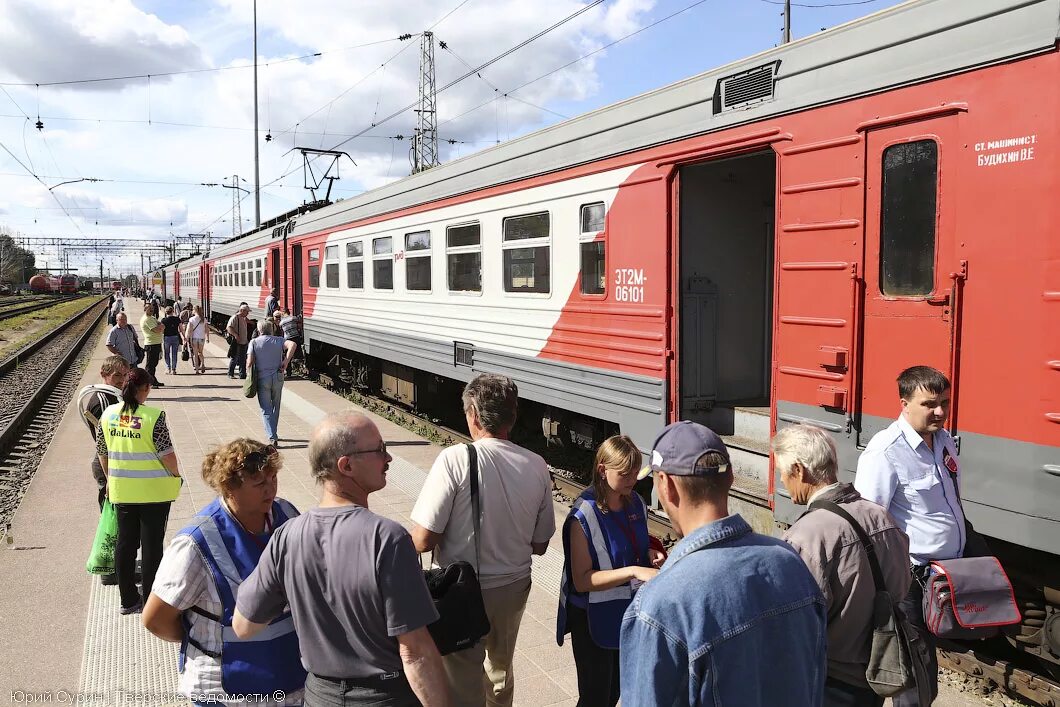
0;0;654;267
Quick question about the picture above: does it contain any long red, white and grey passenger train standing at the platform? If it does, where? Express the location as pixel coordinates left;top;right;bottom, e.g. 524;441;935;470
160;0;1060;664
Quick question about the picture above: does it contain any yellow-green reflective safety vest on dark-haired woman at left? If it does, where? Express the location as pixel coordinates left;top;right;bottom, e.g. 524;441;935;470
101;403;180;503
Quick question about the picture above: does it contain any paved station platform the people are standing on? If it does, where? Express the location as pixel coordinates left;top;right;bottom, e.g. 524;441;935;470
0;337;578;706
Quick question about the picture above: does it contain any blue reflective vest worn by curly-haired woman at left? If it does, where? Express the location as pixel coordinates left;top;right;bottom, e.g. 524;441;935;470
178;498;305;695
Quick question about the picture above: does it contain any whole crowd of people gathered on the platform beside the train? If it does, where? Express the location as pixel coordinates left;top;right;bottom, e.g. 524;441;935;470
80;296;987;707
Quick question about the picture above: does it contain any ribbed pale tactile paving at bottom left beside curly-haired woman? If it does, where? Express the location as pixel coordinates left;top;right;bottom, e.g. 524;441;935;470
78;579;190;707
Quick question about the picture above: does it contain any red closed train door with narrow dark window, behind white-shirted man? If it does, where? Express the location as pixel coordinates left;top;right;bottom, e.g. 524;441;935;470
858;106;964;446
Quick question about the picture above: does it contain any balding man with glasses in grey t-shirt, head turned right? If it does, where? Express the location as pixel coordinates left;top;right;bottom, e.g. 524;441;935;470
232;412;449;707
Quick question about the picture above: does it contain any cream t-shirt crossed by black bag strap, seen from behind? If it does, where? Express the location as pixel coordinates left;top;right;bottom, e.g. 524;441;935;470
411;438;555;589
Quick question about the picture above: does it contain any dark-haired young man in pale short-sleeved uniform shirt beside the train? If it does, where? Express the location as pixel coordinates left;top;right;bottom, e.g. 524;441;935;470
854;366;989;707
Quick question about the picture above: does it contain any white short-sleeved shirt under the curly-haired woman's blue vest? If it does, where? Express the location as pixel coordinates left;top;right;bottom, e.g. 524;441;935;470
151;525;304;707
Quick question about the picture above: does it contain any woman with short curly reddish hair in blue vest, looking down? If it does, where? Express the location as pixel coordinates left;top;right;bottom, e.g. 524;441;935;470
143;439;305;706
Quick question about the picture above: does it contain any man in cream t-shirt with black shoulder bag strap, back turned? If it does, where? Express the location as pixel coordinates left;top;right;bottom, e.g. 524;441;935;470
411;374;555;706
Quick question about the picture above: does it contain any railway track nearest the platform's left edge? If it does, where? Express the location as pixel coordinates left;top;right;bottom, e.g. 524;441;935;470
0;300;107;535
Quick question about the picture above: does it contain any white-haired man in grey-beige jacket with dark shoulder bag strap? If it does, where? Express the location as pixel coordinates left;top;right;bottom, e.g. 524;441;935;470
773;424;909;707
